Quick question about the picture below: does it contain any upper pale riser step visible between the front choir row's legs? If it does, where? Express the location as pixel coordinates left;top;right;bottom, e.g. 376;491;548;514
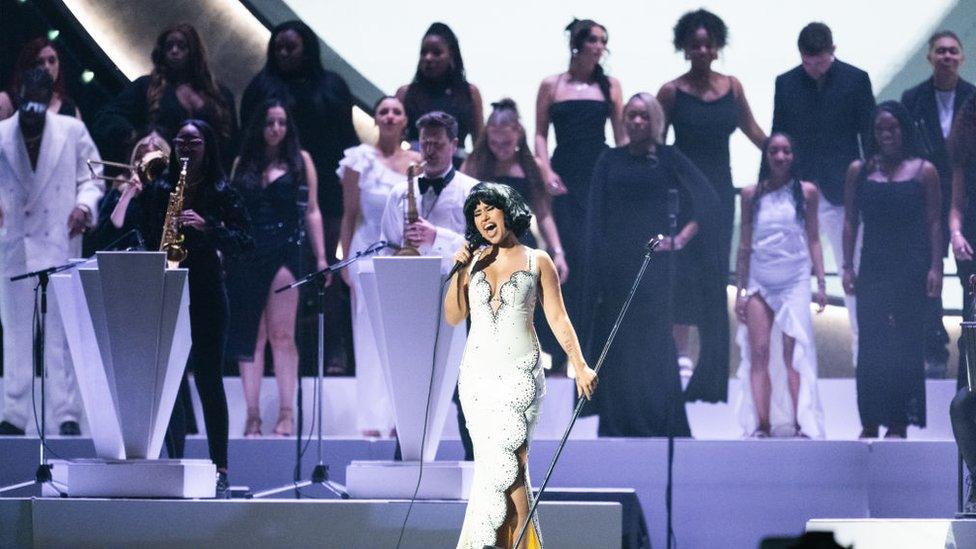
0;377;956;440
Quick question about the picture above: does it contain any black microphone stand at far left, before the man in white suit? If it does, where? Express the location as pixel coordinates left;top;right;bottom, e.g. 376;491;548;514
0;260;84;494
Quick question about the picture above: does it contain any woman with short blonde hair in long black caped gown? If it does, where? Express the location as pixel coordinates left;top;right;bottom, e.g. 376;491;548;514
584;93;728;436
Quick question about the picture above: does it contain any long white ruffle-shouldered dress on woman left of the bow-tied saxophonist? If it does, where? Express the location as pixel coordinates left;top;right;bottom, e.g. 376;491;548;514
336;143;407;435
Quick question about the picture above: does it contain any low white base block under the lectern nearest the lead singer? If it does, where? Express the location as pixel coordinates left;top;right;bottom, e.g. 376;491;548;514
346;461;474;499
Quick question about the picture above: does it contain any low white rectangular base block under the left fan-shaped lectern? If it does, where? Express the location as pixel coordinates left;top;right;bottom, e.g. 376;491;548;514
43;459;217;498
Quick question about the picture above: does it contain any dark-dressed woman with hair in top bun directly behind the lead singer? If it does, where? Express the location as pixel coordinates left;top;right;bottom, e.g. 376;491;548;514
461;99;569;365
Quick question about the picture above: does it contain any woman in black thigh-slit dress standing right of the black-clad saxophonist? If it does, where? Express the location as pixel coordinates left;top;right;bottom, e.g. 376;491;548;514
227;99;328;436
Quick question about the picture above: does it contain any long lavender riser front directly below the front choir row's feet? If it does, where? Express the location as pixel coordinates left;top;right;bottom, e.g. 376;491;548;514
0;437;957;547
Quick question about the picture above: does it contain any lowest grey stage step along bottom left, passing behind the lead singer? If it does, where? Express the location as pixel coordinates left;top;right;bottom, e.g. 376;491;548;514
0;499;622;549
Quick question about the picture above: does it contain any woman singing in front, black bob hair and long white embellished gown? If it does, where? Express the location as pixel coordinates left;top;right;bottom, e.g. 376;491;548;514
444;183;596;549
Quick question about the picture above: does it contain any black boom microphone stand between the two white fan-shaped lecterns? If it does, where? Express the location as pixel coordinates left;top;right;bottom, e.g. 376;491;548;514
252;240;398;499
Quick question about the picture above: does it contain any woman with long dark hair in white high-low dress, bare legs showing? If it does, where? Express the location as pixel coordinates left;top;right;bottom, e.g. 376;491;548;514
735;133;827;438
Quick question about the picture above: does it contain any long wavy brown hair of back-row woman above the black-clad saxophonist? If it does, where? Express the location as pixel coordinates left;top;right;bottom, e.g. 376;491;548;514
146;23;232;138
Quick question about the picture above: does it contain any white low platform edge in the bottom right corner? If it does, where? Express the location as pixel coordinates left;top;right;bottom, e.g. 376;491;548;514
807;519;976;549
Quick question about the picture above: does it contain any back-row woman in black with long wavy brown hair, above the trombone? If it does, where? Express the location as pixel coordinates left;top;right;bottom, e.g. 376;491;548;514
92;23;237;170
